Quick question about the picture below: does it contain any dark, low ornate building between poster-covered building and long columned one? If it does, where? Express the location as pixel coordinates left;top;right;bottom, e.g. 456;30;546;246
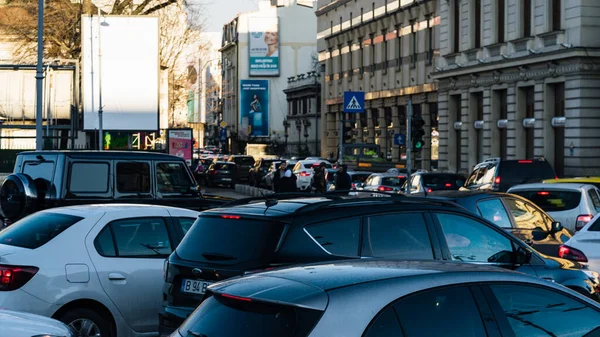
283;71;321;156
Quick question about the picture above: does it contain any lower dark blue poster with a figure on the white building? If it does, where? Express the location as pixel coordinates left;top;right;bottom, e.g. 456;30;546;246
240;80;269;139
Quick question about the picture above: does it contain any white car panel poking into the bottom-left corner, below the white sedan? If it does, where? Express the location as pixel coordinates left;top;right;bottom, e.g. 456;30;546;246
0;309;73;337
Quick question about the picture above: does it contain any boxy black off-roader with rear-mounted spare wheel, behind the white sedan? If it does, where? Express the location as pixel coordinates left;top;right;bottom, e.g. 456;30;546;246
0;151;224;223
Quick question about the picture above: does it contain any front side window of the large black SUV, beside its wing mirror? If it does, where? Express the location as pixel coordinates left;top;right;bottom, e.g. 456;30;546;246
436;213;513;263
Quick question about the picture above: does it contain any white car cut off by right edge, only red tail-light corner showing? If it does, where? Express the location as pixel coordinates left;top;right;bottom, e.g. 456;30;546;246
560;214;600;270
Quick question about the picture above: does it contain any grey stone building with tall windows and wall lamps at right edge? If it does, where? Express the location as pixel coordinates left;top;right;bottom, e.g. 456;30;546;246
434;0;600;176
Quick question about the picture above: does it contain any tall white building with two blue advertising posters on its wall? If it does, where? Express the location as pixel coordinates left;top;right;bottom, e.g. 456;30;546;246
220;0;317;153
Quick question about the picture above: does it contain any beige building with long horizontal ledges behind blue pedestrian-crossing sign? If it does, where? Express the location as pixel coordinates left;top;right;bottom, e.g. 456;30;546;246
317;0;443;169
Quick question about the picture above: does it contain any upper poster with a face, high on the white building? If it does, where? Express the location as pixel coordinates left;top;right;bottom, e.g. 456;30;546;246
248;18;279;76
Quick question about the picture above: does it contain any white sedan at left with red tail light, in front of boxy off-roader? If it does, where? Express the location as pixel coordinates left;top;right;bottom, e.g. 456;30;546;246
0;204;199;337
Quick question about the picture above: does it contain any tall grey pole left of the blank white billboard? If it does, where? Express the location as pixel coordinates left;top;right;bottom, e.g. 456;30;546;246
35;0;45;151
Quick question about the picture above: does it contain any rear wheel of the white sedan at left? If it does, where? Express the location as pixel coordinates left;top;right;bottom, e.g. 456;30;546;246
58;308;116;337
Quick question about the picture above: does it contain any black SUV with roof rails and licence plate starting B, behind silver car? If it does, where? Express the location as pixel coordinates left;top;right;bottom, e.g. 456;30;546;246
159;192;598;334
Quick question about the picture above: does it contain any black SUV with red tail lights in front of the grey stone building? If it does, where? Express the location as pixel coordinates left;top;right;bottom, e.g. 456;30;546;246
463;158;556;192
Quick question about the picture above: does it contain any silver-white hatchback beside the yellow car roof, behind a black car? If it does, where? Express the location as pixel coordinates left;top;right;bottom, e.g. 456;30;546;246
508;183;600;233
